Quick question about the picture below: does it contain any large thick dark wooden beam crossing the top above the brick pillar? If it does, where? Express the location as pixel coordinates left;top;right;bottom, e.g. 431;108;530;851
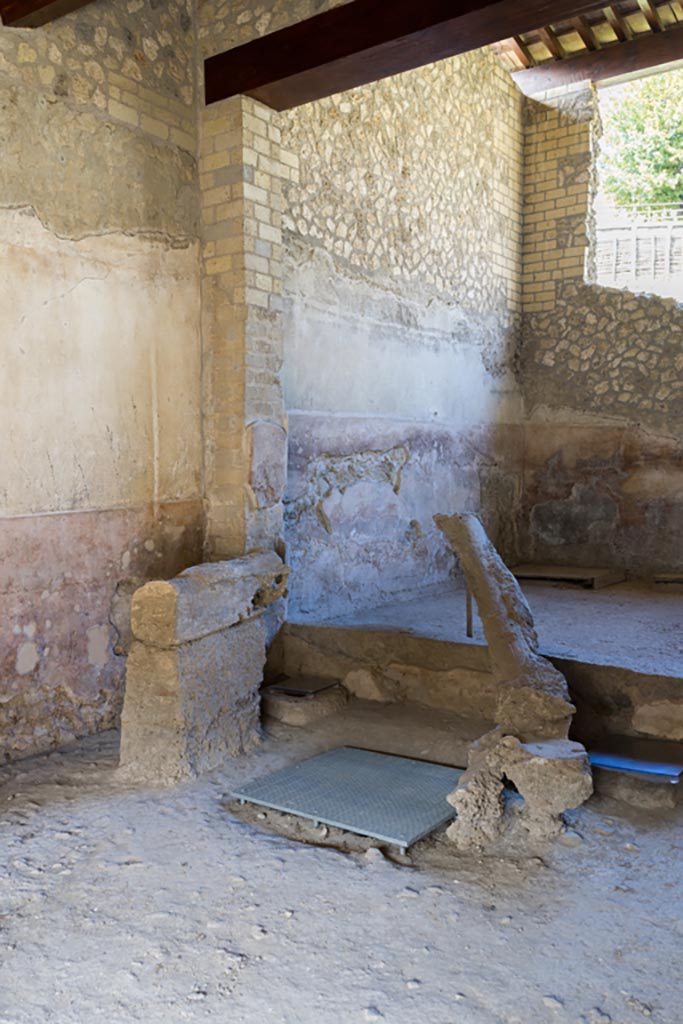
205;0;610;111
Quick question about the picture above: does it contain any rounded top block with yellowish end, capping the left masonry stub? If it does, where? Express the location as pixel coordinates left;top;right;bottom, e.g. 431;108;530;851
131;552;289;647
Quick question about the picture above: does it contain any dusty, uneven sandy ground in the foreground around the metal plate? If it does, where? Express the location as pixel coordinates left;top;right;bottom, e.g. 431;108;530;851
0;718;683;1024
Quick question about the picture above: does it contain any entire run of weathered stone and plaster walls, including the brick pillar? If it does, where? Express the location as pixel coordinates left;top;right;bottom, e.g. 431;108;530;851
6;0;683;760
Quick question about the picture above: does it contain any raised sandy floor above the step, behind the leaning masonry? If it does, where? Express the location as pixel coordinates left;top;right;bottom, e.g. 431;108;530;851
317;583;683;679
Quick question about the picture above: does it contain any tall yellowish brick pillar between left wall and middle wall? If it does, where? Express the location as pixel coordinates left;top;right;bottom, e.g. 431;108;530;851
200;96;298;559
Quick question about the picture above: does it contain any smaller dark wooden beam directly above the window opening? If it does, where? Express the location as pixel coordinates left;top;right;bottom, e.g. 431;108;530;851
512;19;683;96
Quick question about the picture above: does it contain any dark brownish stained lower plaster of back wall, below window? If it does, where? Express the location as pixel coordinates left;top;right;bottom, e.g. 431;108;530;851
520;423;683;577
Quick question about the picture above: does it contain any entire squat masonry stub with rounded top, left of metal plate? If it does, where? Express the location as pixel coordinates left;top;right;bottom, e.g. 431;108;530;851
120;553;289;783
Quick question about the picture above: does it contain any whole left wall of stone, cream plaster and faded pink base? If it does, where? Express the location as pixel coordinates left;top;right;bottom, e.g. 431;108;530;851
0;0;203;759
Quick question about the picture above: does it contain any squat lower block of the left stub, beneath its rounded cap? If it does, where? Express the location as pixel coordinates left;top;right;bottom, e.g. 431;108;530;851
121;615;265;782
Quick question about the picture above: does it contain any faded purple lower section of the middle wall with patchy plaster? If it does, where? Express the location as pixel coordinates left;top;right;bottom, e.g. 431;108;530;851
286;414;521;620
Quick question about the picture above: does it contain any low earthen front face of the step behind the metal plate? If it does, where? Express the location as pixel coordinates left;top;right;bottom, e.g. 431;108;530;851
268;623;683;745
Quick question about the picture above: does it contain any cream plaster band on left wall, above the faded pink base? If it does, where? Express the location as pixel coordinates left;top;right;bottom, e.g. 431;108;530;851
0;210;202;516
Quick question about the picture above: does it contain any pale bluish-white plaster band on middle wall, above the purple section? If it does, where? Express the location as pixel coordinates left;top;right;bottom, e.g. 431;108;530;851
283;250;521;429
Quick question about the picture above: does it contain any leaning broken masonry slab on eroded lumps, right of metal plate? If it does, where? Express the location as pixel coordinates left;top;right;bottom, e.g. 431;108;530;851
434;514;593;849
